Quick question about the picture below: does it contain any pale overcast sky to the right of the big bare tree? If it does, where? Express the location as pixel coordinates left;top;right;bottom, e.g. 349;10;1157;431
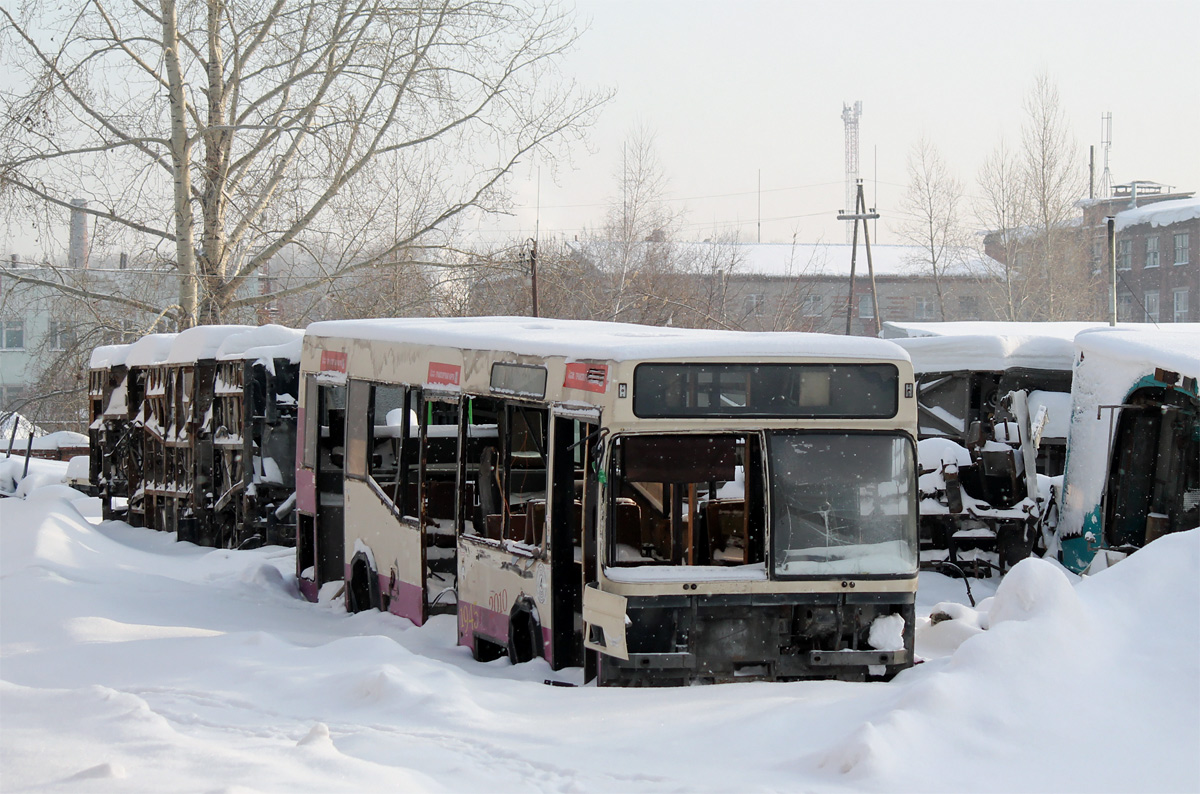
496;0;1200;242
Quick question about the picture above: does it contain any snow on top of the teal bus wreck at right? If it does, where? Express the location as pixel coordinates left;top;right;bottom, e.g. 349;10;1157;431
1075;323;1200;378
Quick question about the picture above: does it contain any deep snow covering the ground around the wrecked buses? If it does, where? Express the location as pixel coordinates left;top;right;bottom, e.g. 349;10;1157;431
0;485;1200;794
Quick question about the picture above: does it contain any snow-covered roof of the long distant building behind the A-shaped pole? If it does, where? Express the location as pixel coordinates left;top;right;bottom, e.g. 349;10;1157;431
572;241;989;278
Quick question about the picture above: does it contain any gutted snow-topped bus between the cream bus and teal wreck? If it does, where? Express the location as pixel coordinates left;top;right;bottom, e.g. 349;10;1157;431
882;321;1100;576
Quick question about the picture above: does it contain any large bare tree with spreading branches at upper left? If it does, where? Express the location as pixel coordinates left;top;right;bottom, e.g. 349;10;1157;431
0;0;606;326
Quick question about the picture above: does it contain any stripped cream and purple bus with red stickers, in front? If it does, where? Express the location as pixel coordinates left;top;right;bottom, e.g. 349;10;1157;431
296;318;918;685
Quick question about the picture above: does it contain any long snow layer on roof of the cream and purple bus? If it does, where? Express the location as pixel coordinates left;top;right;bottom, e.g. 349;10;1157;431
306;317;908;361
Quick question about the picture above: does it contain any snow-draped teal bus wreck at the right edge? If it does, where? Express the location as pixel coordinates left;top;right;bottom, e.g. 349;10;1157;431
1057;323;1200;571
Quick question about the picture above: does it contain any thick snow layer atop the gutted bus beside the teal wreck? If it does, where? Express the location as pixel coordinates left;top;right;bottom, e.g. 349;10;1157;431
883;323;1108;372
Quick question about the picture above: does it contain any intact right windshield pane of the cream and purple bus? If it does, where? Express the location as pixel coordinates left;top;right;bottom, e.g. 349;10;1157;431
768;432;917;578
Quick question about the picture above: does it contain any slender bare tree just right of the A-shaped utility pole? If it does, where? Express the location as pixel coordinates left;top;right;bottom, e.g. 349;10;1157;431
899;136;967;320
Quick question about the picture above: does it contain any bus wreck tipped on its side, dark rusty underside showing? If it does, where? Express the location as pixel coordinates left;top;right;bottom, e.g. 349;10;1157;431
89;325;301;548
